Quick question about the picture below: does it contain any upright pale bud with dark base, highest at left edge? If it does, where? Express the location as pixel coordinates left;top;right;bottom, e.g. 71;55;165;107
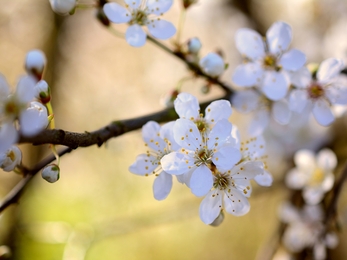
25;50;46;80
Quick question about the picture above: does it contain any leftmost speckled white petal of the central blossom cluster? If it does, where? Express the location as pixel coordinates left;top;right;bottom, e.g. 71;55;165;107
129;154;159;176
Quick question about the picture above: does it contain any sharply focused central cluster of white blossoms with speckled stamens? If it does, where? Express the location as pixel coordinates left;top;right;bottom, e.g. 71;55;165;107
129;93;272;224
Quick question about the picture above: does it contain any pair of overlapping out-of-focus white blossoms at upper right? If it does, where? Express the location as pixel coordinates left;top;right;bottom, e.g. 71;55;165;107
232;22;347;135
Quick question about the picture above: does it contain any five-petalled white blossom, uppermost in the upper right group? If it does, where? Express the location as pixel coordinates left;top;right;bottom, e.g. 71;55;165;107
232;22;306;101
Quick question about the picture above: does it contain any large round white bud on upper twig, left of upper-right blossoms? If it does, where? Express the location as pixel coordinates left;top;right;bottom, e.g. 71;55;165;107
199;52;225;77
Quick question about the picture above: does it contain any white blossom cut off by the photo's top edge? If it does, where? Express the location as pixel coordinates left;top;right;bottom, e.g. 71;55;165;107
104;0;176;47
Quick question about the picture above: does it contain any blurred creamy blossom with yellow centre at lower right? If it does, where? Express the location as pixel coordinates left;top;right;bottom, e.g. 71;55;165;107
286;148;337;204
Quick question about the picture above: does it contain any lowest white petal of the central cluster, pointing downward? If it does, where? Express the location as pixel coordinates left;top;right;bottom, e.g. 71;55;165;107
199;190;223;224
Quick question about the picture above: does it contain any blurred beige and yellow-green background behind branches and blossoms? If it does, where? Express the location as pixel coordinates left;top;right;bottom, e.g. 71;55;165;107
0;0;347;260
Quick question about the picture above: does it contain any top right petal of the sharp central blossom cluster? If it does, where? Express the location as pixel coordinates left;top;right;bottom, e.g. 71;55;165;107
205;100;232;124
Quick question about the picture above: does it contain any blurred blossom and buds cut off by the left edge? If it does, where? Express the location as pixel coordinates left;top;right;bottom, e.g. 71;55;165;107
0;50;49;174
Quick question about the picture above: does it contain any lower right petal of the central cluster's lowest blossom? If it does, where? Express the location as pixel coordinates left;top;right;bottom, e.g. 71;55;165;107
224;188;251;216
